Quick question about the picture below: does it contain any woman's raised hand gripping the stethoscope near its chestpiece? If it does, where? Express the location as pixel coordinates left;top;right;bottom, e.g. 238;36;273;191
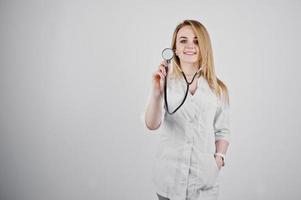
153;60;167;97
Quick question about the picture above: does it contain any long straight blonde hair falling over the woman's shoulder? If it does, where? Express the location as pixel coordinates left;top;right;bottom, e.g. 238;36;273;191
171;20;229;104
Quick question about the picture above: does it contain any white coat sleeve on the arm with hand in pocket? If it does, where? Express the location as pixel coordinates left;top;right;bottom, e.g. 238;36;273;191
214;95;231;142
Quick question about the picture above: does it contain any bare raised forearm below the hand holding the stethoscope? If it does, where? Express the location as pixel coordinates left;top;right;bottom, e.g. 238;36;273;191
145;95;162;130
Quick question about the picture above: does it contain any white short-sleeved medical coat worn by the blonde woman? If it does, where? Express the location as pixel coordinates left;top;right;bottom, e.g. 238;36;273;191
143;76;230;200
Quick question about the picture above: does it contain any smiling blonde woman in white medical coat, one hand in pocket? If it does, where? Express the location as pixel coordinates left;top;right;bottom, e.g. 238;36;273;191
144;20;230;200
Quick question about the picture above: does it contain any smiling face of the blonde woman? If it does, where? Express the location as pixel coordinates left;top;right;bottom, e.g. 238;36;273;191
176;26;200;65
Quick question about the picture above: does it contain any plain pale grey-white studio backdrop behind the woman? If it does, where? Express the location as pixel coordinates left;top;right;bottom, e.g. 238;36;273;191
0;0;301;200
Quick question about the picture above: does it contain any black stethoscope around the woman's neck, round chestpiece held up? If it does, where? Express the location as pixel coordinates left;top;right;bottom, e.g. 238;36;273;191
162;48;203;115
